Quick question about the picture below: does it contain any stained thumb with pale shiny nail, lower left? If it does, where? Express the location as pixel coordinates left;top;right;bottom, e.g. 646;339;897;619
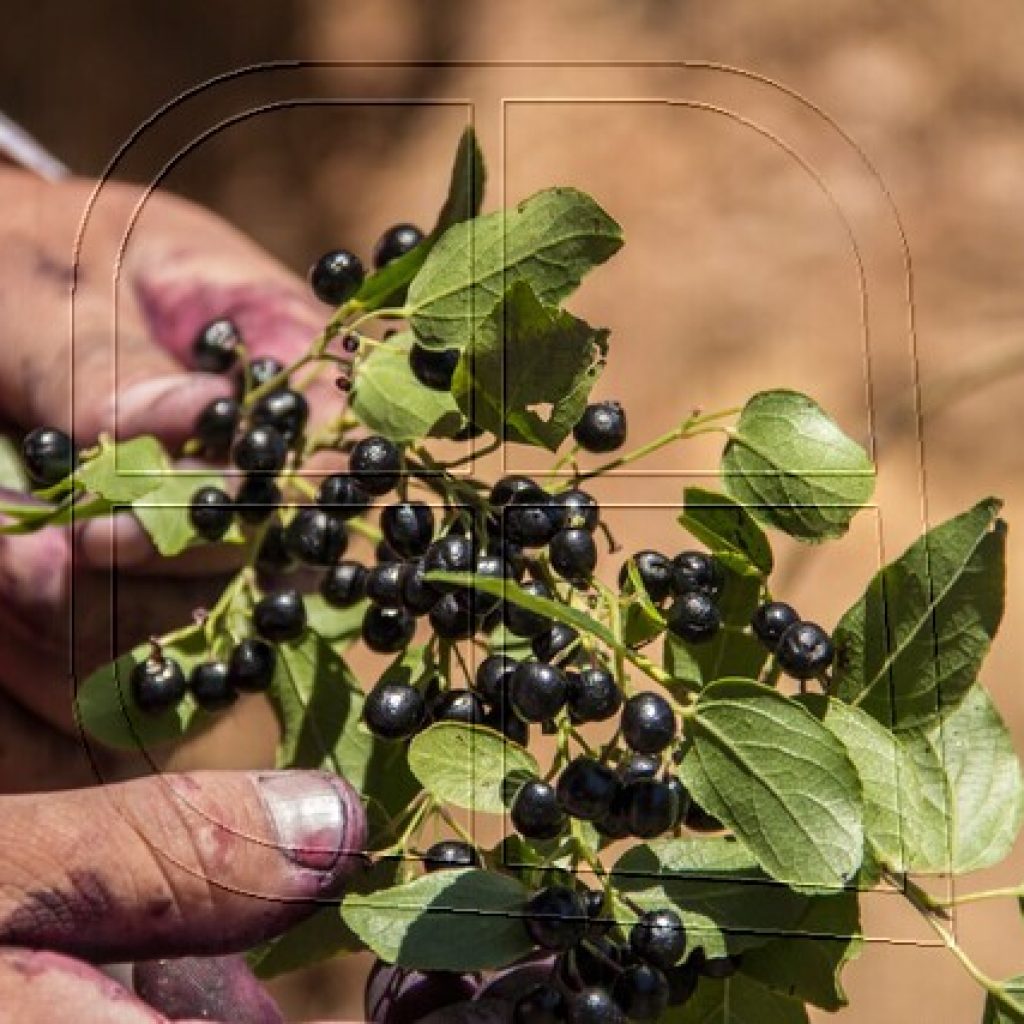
0;771;366;962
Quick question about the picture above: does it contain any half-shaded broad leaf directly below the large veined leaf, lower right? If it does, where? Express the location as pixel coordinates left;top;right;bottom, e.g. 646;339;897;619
612;837;807;956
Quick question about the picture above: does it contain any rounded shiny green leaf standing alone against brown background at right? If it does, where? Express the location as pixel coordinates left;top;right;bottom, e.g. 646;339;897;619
722;391;874;541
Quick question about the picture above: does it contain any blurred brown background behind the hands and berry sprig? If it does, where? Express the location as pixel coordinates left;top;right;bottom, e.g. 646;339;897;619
0;0;1024;1024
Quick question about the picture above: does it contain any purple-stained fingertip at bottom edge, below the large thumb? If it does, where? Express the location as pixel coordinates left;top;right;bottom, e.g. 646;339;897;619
133;955;284;1024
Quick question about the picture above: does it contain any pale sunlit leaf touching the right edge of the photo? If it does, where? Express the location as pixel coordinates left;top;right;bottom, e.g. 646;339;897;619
901;686;1024;874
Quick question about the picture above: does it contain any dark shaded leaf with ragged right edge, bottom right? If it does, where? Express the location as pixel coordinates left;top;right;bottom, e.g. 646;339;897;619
739;892;864;1012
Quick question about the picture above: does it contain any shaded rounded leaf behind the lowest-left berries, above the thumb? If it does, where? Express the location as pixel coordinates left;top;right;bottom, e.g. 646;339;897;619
75;626;207;751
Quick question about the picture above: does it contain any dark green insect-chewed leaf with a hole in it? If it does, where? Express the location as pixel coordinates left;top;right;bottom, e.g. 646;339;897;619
452;281;607;452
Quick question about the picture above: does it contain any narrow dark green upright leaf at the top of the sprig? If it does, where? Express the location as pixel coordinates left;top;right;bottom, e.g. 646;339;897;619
353;128;485;311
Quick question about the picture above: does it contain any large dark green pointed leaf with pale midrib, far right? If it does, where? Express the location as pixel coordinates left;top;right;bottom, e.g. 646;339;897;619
831;499;1006;730
